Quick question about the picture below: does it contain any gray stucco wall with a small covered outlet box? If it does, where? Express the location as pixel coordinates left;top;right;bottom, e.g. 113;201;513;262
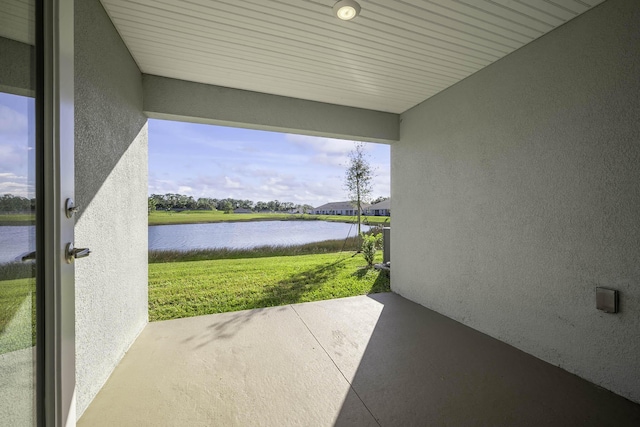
391;0;640;402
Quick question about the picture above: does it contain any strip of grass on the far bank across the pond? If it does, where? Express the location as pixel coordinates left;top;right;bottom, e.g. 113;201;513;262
149;211;389;225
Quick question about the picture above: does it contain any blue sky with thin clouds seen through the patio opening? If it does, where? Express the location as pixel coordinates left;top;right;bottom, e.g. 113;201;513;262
149;120;390;206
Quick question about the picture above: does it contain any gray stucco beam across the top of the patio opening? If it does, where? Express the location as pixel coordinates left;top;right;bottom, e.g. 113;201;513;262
143;74;399;143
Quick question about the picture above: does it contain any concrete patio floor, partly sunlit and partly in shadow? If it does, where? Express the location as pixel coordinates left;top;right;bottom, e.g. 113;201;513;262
79;293;640;427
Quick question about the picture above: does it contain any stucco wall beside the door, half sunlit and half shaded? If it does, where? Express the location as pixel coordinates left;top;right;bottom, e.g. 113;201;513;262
75;0;148;416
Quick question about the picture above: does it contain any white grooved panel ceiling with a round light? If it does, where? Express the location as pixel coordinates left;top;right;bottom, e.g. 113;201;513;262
97;0;603;113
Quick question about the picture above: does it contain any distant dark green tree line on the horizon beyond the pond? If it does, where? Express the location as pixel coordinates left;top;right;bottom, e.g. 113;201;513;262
149;193;313;213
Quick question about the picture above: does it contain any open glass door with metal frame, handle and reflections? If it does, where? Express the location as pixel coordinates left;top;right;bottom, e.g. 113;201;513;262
0;0;75;426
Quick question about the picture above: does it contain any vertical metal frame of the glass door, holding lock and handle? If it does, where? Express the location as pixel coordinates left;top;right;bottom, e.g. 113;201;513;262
36;0;76;426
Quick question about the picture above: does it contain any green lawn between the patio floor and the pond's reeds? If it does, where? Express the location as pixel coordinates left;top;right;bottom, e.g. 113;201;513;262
149;252;390;321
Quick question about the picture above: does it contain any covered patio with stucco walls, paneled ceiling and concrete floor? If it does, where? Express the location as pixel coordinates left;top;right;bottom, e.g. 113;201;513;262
0;0;640;426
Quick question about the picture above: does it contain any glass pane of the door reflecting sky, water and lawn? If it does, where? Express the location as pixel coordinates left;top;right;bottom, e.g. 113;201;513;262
0;0;41;426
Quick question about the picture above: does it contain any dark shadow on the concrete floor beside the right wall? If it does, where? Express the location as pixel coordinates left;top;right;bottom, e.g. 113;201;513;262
329;293;640;426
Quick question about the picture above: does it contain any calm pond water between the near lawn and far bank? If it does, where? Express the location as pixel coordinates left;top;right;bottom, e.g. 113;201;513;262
149;221;369;250
